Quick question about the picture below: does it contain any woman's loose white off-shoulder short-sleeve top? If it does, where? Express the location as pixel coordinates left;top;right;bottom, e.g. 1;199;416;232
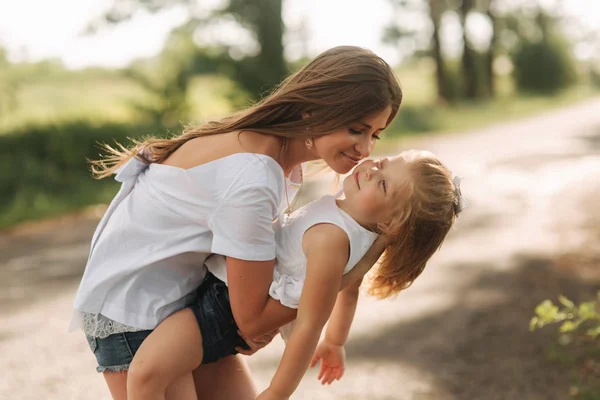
71;153;297;329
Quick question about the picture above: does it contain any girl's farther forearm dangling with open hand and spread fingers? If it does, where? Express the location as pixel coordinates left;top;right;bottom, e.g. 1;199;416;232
310;280;362;385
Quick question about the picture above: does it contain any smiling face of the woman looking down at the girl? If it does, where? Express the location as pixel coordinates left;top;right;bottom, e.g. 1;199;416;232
314;107;392;174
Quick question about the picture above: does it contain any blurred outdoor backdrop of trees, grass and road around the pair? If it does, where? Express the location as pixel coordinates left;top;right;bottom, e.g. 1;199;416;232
0;0;600;400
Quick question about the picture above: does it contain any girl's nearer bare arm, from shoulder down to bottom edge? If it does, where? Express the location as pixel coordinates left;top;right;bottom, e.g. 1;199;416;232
258;224;350;399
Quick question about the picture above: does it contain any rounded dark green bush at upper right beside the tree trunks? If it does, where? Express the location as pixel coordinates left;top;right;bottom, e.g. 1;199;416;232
513;37;576;94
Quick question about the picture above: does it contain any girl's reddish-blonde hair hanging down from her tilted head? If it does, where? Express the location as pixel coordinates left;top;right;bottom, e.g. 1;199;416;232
369;150;460;298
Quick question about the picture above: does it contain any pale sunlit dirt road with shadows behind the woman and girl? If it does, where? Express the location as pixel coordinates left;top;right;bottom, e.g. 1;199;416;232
0;99;600;400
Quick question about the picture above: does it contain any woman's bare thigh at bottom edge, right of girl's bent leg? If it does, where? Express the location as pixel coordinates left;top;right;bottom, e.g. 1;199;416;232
193;355;257;400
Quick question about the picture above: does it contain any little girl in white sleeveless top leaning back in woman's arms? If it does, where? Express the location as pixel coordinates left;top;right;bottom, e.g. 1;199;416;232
127;150;461;400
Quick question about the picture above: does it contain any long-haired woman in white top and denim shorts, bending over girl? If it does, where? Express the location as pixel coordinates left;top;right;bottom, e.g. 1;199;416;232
74;46;402;399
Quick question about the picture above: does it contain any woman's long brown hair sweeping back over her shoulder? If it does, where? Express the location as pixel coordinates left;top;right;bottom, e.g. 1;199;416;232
91;46;402;179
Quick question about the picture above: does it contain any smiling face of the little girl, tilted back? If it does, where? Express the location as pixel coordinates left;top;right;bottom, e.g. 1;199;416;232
344;155;410;226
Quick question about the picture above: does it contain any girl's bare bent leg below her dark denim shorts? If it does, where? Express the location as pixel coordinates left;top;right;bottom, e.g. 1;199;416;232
127;308;203;400
